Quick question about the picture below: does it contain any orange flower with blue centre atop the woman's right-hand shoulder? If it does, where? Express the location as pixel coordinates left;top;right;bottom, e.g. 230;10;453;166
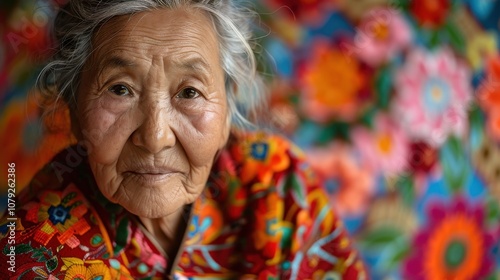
234;133;290;186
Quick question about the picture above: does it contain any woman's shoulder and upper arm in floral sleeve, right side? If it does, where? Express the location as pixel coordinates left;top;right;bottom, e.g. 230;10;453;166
215;132;366;279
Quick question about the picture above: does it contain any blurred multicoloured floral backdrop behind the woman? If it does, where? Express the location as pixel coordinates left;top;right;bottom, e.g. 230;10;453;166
0;0;500;279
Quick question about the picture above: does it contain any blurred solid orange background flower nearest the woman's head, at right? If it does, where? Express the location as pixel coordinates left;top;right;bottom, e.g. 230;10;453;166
301;41;367;122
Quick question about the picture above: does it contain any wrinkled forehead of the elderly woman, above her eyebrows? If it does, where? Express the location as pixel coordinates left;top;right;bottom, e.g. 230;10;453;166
91;8;219;68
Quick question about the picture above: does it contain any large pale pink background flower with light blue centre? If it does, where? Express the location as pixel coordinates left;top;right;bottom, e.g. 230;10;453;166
393;49;472;146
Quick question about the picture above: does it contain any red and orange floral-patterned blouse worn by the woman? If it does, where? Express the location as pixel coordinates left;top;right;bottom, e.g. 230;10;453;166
0;132;368;280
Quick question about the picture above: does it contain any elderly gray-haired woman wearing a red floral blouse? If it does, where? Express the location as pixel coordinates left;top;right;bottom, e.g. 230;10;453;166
0;0;367;279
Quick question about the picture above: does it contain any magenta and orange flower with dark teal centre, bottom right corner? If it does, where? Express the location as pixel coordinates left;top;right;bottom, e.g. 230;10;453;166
403;197;494;279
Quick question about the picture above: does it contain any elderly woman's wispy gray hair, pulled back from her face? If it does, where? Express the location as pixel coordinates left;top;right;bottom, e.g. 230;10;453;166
37;0;267;129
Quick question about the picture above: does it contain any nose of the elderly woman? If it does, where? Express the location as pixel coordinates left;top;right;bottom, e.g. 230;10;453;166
132;102;176;154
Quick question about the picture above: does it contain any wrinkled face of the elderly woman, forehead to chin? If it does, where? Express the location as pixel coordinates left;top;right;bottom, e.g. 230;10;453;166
74;9;229;218
